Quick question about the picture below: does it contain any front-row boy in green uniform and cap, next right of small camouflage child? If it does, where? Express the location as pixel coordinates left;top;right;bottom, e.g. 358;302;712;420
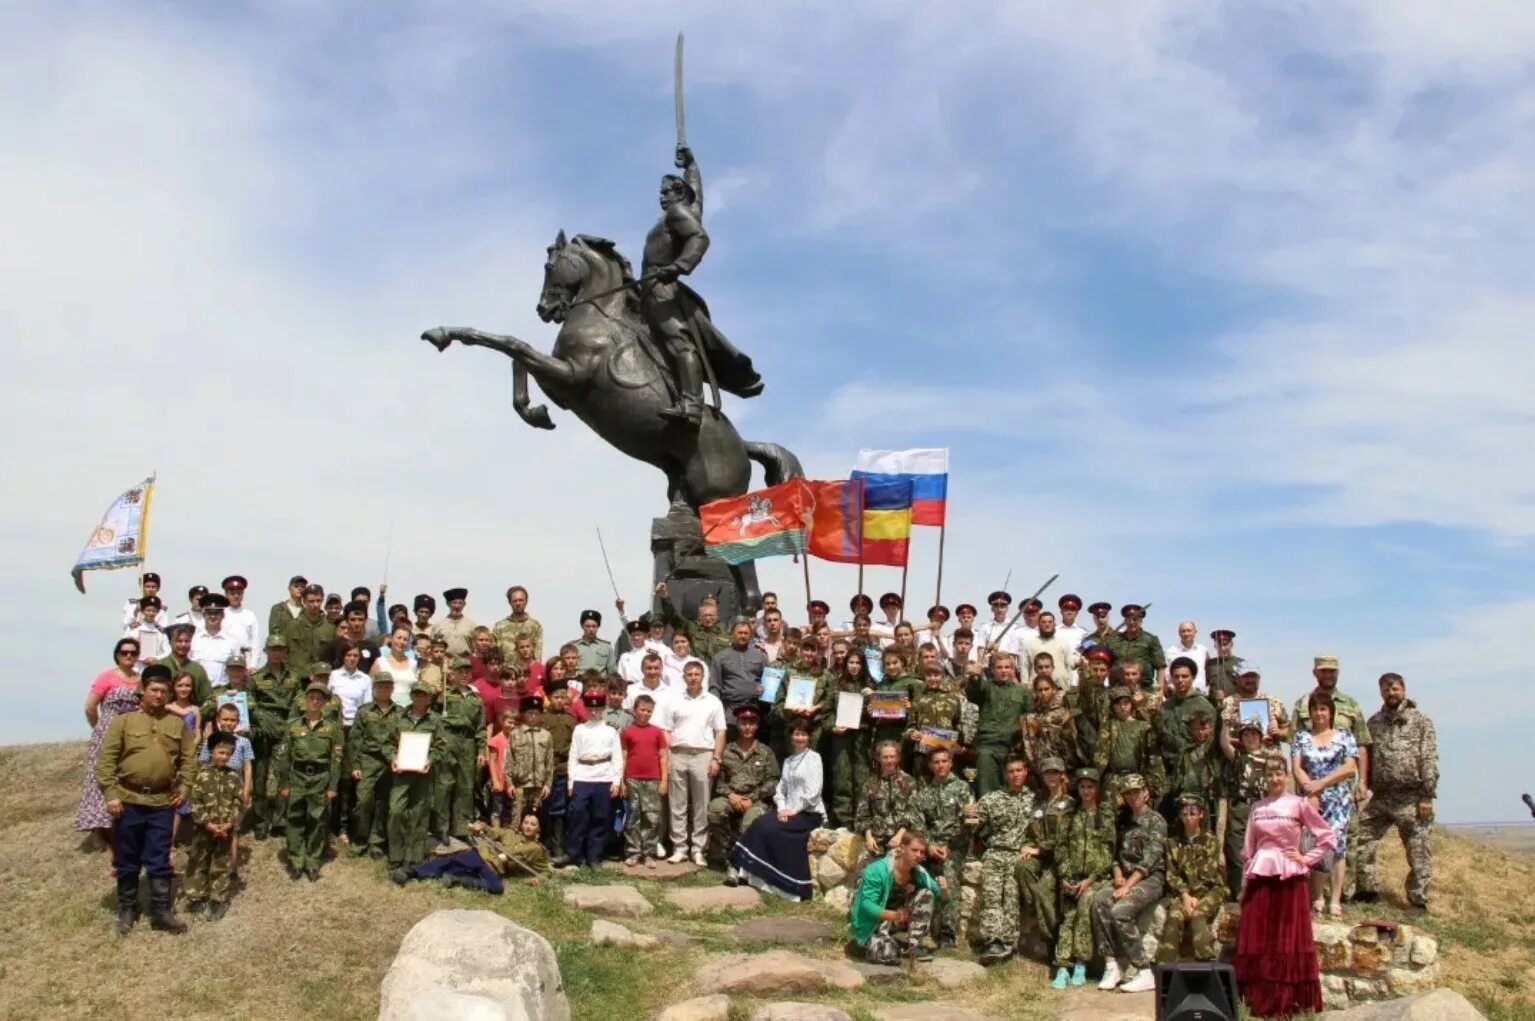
276;682;345;883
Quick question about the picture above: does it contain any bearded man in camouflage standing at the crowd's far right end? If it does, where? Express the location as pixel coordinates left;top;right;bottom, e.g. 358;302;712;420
1354;674;1438;910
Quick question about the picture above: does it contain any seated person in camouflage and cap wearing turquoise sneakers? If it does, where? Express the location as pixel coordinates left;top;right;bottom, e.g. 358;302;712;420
1050;769;1114;989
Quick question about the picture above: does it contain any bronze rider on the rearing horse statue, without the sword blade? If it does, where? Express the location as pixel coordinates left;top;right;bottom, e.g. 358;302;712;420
640;146;763;428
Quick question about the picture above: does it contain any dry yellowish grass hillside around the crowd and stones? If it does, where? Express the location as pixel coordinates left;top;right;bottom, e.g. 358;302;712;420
0;743;1535;1021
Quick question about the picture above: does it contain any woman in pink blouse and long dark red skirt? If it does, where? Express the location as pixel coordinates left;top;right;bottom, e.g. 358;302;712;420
1233;755;1335;1018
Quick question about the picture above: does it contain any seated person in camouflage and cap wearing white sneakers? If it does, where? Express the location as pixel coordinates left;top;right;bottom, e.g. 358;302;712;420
1093;774;1167;993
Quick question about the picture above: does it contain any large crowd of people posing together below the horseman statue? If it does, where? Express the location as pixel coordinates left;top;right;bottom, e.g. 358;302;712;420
77;574;1438;1016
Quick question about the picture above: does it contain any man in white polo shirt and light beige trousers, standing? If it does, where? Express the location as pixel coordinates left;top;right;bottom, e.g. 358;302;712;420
657;660;725;866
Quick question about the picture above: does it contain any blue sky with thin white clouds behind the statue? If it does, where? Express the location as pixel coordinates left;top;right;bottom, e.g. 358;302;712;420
0;2;1535;821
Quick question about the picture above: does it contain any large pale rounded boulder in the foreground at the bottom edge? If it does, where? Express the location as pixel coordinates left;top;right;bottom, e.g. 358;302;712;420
379;910;571;1021
